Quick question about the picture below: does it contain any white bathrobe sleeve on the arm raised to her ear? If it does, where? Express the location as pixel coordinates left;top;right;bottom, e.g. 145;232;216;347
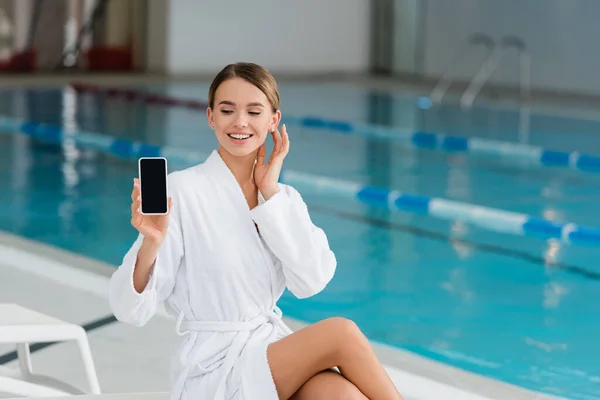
251;184;337;298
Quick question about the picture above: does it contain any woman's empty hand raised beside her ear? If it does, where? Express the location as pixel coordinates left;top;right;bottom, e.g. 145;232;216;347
254;124;290;200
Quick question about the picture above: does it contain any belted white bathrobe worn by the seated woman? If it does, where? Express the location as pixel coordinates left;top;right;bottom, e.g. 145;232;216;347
110;151;336;400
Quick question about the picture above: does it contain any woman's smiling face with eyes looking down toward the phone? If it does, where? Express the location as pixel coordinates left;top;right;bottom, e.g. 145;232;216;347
206;78;281;156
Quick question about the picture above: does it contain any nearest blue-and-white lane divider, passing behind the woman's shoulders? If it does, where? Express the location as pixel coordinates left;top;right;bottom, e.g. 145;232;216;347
0;117;600;247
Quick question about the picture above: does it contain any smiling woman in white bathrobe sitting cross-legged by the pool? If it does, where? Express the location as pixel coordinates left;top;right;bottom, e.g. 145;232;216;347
110;63;401;400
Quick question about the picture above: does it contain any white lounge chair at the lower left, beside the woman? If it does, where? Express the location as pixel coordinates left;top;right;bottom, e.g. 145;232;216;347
0;303;100;397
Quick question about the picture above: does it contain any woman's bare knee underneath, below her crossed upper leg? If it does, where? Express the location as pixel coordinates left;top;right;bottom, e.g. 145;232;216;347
290;370;368;400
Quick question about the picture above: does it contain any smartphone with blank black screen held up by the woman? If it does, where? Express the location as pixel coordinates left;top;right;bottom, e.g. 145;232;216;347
138;157;169;215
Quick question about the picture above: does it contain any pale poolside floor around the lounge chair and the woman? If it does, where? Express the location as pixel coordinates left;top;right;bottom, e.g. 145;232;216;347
0;233;560;400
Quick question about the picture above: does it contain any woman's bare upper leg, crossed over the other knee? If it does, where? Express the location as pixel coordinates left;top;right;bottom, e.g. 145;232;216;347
267;318;402;400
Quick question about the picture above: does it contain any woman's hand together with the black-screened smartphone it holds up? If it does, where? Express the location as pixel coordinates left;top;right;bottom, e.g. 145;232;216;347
131;157;171;245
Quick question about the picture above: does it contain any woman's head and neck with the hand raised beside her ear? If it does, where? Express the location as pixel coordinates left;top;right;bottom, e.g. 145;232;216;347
206;63;289;209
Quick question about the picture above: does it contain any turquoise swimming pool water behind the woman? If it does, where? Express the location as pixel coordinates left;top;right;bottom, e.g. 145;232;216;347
0;84;600;399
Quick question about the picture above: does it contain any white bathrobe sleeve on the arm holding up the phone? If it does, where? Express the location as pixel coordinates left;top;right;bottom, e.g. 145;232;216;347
109;172;183;326
